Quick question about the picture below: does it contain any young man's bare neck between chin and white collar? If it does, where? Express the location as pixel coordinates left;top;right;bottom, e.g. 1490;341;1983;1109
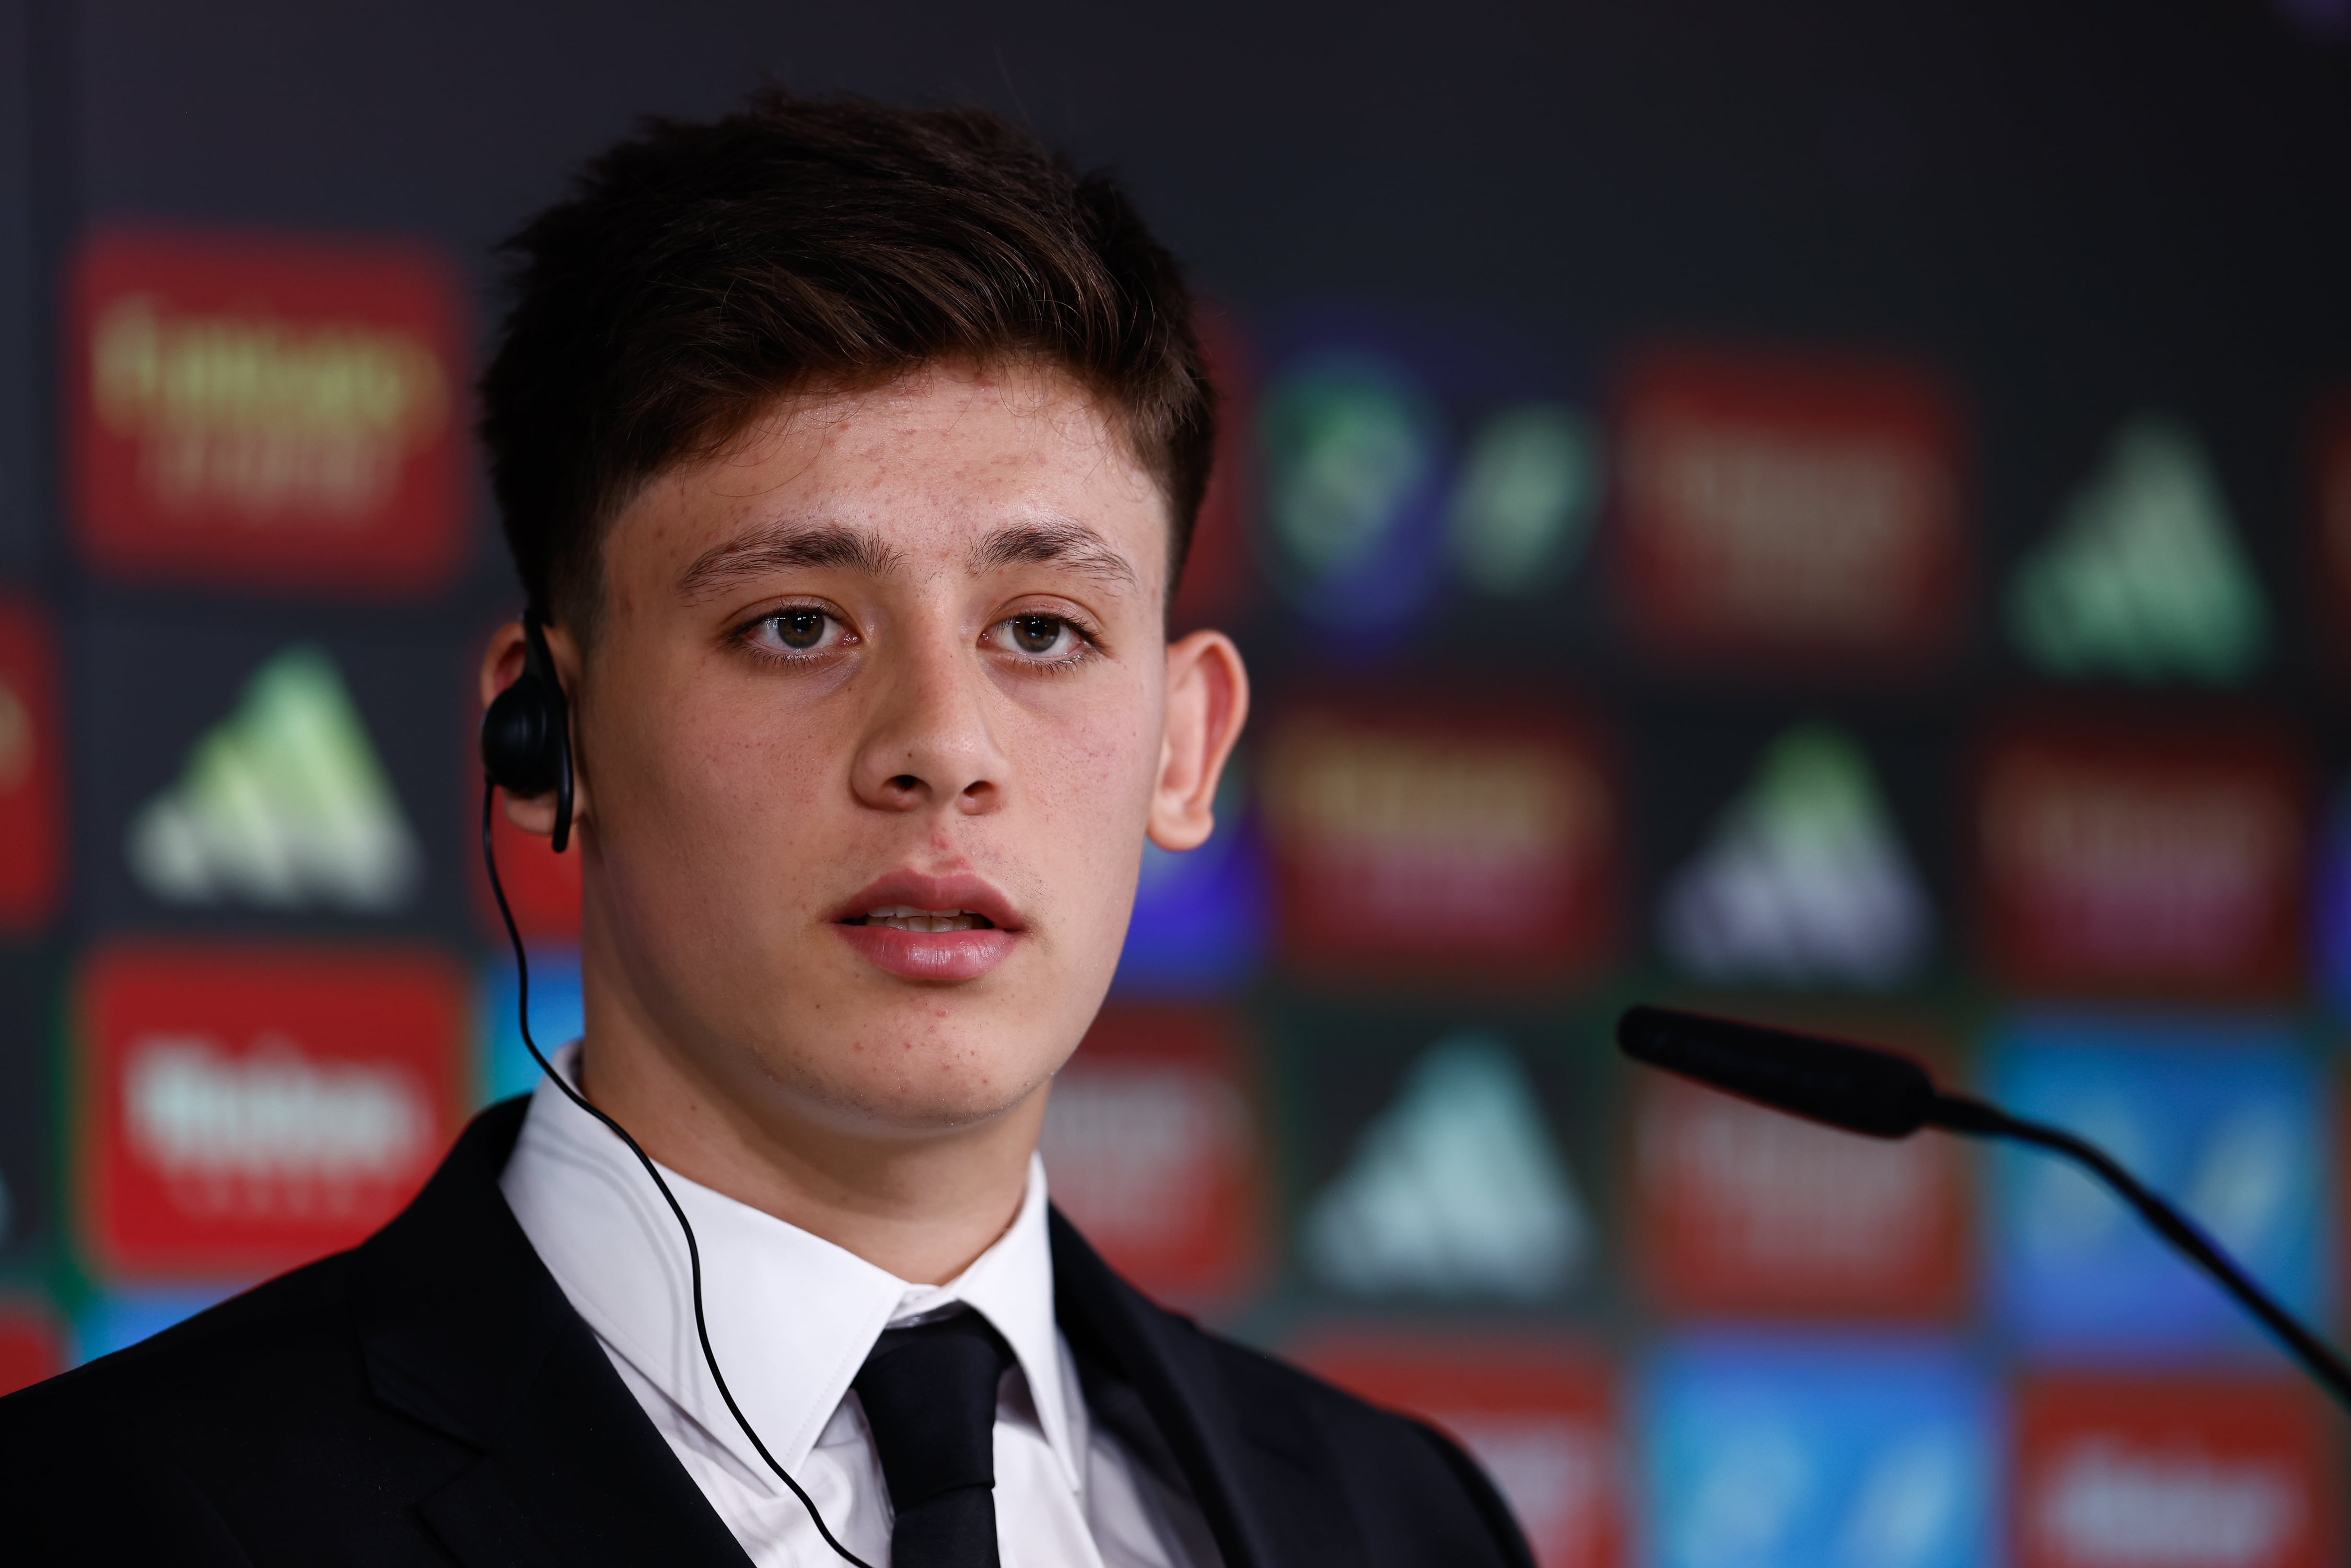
564;969;1046;1286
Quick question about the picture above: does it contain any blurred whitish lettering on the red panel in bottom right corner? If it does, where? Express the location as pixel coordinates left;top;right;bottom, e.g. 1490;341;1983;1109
2031;1439;2307;1568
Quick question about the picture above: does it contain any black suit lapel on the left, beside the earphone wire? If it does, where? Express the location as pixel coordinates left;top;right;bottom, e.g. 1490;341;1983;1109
357;1100;750;1568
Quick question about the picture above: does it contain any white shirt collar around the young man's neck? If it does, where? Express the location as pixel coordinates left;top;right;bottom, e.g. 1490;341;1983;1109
498;1044;1084;1491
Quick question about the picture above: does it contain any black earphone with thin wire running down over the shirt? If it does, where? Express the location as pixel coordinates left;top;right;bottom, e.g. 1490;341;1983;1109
482;609;872;1568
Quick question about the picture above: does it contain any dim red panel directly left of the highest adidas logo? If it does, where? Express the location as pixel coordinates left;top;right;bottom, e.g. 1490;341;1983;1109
1617;350;1965;668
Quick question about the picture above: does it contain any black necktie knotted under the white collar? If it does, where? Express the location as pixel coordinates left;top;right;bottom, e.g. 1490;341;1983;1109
854;1309;1014;1568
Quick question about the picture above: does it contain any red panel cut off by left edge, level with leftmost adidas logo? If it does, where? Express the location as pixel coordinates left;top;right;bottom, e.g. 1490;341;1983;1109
0;599;66;931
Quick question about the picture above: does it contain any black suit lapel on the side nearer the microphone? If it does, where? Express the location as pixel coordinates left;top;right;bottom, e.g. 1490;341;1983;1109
1051;1211;1364;1568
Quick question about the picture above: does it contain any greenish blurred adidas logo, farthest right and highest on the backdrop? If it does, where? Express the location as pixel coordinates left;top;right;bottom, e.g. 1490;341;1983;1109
2008;416;2269;687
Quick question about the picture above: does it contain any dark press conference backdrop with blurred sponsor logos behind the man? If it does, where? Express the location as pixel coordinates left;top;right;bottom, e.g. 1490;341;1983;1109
0;0;2351;1568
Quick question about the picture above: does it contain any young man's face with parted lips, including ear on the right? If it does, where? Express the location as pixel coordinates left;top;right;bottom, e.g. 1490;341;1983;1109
494;369;1246;1135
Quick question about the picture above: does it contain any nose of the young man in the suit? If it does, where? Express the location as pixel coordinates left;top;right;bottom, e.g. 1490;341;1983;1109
849;635;1009;816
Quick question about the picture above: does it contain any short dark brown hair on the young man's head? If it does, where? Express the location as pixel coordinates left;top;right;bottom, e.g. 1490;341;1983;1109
482;89;1216;637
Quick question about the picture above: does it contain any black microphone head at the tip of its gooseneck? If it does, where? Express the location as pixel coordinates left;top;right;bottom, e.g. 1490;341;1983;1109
1617;1006;1937;1138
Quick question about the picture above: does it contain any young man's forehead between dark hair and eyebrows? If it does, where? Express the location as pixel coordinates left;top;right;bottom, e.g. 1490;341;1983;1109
607;367;1169;590
